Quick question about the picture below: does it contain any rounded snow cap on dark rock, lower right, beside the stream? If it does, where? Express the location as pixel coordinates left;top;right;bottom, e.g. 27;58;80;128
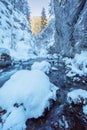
67;89;87;104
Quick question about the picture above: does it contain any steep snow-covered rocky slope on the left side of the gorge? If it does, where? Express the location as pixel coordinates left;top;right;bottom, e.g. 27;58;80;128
0;0;35;59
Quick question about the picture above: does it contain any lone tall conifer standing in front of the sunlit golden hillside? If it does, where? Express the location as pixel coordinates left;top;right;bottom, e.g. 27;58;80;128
41;8;47;29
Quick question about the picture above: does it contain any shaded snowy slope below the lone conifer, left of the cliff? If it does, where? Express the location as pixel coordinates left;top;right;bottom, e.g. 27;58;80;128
36;18;55;57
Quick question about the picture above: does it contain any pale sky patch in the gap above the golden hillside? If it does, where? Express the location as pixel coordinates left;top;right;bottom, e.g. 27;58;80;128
28;0;49;16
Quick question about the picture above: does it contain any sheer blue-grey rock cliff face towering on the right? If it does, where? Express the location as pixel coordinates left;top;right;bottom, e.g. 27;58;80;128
54;0;87;56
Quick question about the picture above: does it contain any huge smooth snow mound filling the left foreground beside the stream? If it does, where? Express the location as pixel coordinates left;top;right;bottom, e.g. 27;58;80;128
0;70;58;130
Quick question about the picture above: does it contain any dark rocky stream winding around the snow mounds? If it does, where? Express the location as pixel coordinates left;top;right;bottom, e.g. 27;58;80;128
0;58;87;130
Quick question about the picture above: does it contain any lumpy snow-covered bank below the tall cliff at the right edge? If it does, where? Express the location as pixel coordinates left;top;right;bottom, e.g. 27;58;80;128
64;51;87;77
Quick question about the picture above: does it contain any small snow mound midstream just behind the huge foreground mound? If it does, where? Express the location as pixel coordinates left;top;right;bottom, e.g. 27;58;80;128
31;61;51;73
